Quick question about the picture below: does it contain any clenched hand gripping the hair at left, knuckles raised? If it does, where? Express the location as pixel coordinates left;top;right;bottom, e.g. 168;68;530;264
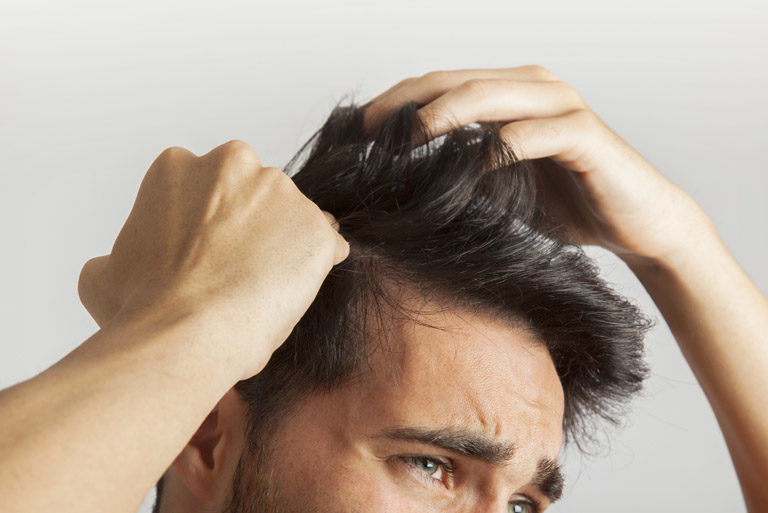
79;140;349;379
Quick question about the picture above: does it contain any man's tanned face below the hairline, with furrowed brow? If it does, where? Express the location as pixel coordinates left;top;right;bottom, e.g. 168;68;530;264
200;306;563;513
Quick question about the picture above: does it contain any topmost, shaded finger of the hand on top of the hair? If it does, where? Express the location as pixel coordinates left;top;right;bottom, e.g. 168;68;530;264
363;65;557;129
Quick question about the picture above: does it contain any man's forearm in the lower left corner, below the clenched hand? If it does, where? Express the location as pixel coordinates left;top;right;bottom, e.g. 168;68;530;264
0;304;246;513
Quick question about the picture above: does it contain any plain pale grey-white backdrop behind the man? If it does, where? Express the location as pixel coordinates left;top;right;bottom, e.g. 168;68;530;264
0;0;768;513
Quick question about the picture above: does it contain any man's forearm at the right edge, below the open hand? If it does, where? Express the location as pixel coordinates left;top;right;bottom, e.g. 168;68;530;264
630;230;768;511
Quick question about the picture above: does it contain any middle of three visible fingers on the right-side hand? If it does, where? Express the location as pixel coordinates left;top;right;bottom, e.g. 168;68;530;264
419;79;587;141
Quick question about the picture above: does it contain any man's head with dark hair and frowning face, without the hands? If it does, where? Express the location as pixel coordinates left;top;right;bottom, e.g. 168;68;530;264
154;104;649;513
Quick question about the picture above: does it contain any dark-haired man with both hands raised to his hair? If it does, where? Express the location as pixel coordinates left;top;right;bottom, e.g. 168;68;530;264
0;66;768;513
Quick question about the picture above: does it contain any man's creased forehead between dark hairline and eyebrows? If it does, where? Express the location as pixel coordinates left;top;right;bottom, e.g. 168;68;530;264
353;296;563;458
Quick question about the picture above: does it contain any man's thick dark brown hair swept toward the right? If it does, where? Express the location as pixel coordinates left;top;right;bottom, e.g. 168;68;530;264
237;98;653;450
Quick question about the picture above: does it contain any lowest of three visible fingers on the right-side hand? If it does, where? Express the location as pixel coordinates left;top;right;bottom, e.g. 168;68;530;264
499;110;605;172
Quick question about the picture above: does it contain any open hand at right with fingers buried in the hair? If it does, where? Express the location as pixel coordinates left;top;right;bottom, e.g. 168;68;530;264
365;66;715;263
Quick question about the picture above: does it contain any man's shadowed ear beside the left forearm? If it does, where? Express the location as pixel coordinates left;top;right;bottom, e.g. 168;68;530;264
171;388;245;502
